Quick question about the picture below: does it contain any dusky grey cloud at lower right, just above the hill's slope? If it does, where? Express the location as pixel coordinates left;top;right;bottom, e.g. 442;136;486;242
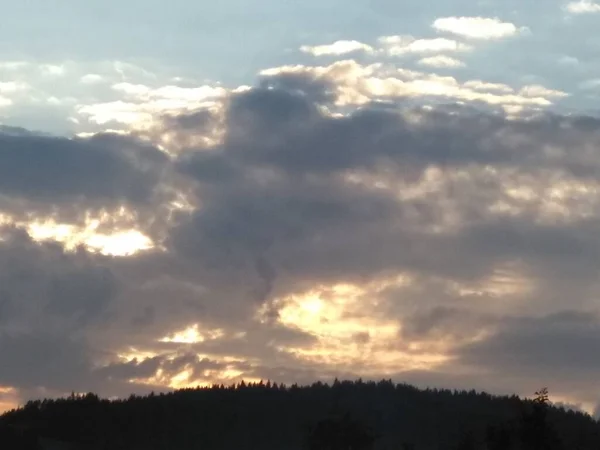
442;305;600;402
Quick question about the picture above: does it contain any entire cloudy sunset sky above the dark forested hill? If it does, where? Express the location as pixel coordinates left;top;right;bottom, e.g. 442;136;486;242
0;0;600;413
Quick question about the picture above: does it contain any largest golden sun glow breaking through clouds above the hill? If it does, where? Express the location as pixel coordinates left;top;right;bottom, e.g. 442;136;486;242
259;284;447;375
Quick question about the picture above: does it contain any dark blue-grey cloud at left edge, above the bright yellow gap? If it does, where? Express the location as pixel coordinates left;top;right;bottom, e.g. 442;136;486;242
0;130;166;205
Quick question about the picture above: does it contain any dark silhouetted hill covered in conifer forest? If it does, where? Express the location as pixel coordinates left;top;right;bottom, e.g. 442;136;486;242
0;381;600;450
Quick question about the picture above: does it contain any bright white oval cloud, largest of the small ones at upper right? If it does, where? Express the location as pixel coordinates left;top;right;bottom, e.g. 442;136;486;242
432;17;525;40
